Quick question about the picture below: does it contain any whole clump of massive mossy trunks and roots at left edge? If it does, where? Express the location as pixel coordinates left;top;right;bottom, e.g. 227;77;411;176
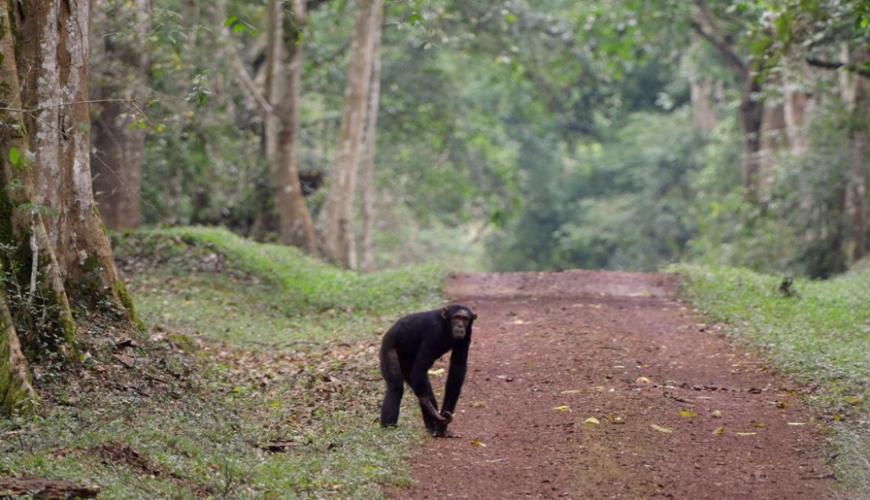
0;0;138;412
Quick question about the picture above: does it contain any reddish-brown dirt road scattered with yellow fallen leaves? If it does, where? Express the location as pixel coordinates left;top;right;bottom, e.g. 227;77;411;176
389;271;834;500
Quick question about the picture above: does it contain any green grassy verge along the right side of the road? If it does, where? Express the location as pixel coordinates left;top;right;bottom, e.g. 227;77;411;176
673;266;870;498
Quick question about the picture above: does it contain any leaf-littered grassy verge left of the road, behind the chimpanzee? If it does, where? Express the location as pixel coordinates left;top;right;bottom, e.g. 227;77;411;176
0;229;444;499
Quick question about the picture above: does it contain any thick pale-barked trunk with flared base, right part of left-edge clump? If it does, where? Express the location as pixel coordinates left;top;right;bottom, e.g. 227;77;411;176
18;1;141;325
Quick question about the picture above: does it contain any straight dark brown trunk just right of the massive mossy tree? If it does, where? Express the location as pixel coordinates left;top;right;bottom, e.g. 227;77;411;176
91;0;150;231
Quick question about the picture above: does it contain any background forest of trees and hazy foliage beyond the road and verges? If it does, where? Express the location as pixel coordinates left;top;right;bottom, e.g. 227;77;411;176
90;0;870;277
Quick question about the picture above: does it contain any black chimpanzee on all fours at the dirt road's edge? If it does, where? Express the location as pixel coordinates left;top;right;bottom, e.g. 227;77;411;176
381;305;477;437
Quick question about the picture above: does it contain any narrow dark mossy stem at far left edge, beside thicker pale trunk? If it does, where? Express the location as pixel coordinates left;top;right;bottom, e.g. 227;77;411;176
0;0;82;413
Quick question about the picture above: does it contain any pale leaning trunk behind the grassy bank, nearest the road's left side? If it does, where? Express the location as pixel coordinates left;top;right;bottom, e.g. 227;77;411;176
317;0;383;269
